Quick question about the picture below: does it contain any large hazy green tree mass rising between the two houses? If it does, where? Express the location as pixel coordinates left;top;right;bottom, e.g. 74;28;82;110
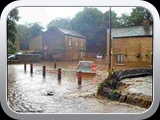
71;7;120;54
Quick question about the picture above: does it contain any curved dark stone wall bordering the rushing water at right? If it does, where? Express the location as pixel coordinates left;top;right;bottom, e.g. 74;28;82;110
97;68;153;109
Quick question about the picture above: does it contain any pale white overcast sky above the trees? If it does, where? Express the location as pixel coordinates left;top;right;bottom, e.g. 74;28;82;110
18;7;133;28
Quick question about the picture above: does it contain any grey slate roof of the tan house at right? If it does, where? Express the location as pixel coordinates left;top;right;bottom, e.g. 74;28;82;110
111;26;152;38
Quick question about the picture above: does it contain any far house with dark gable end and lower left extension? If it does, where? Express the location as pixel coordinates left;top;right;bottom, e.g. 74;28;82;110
29;28;86;61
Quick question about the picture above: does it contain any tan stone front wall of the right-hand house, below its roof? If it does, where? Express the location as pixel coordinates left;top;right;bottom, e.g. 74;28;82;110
112;37;152;69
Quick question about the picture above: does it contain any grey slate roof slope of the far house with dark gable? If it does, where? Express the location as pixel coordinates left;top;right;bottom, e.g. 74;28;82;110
57;28;86;38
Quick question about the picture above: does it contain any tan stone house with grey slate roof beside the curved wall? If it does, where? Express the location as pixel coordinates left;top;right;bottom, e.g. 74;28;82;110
107;26;153;70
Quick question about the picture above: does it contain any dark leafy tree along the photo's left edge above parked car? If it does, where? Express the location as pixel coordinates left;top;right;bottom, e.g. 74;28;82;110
7;9;20;53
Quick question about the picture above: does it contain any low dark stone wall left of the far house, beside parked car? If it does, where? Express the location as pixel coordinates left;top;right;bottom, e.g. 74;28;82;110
16;54;41;63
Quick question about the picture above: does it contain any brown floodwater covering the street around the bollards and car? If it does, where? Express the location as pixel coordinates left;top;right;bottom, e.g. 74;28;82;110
7;60;147;113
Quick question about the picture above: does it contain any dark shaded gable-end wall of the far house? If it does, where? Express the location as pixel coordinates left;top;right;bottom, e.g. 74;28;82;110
42;29;65;61
